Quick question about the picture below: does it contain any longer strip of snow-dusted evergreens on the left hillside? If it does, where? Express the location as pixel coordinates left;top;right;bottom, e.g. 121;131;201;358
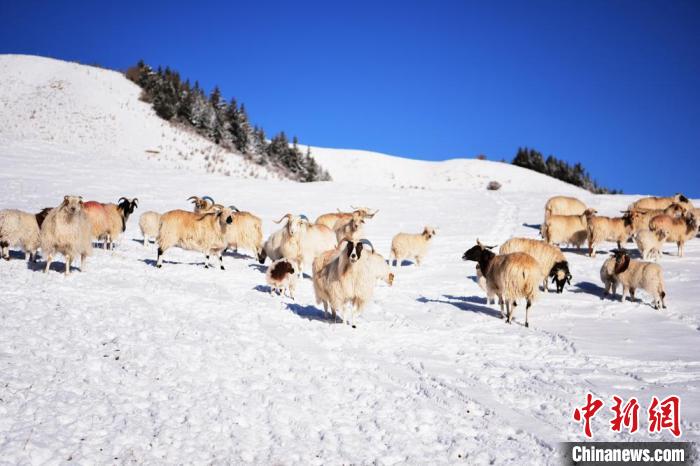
126;60;331;182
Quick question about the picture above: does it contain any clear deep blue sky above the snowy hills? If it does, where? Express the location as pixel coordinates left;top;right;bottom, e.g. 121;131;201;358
0;0;700;197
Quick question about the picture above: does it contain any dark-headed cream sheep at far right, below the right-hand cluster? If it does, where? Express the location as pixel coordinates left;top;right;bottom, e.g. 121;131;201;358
606;249;666;309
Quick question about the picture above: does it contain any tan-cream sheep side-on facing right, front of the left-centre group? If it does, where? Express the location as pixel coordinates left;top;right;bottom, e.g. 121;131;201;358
156;207;233;270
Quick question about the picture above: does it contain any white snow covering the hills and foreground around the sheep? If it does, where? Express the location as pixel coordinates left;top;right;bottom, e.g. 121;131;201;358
0;55;700;464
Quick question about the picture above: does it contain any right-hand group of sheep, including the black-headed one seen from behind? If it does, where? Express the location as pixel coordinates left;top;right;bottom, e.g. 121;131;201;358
462;194;700;327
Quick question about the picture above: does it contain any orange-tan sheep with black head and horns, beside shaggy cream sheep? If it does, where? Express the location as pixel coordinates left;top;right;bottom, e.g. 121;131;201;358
84;197;139;249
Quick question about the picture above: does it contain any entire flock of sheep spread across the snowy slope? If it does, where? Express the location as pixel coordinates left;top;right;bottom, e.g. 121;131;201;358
0;194;700;327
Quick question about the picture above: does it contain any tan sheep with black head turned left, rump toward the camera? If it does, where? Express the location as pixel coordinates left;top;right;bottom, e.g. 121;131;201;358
462;239;546;327
